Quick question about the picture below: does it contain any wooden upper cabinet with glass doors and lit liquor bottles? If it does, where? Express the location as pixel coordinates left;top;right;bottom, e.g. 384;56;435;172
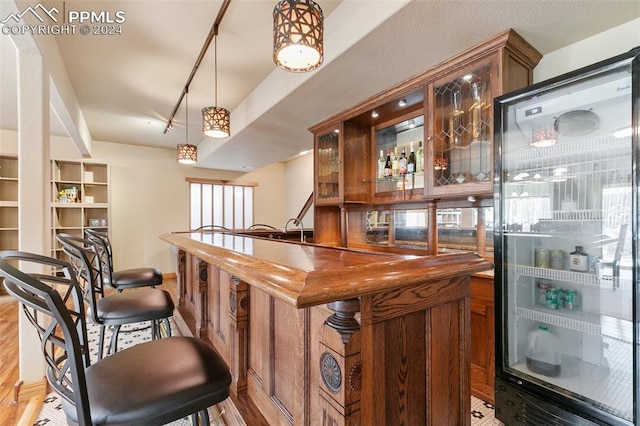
310;30;542;206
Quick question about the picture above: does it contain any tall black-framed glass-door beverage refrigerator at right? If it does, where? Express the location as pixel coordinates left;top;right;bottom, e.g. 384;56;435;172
494;48;640;425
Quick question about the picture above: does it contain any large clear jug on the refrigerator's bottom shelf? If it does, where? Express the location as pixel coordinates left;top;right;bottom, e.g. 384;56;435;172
527;325;562;377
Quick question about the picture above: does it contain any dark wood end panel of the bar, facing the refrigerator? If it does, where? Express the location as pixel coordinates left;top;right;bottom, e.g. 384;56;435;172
361;277;471;426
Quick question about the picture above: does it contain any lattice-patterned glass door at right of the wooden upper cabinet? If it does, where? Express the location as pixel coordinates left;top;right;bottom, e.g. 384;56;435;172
432;64;493;193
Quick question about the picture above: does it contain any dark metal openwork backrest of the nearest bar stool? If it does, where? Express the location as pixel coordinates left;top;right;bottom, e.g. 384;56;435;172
0;251;91;425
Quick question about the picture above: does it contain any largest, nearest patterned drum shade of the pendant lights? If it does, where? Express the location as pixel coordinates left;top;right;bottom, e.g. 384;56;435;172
273;0;324;72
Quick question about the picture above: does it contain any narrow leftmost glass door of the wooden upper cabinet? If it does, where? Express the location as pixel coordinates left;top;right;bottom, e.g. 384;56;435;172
315;127;341;205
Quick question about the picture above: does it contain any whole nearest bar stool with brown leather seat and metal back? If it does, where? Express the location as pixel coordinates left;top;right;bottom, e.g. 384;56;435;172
0;251;231;425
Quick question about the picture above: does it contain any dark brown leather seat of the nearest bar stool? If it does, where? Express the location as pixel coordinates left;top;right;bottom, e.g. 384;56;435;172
63;337;231;425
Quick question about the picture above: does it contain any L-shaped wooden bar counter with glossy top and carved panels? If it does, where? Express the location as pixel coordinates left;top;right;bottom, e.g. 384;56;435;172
161;232;492;426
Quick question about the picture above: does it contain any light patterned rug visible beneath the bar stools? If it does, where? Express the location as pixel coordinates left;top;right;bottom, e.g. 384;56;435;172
33;319;224;426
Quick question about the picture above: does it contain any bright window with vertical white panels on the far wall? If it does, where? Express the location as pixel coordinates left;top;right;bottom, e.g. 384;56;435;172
188;179;256;233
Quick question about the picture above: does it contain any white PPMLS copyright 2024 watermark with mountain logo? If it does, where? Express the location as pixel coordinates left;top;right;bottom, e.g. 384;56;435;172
0;2;126;35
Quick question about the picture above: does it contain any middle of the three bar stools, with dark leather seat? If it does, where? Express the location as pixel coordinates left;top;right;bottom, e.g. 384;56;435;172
56;234;175;359
